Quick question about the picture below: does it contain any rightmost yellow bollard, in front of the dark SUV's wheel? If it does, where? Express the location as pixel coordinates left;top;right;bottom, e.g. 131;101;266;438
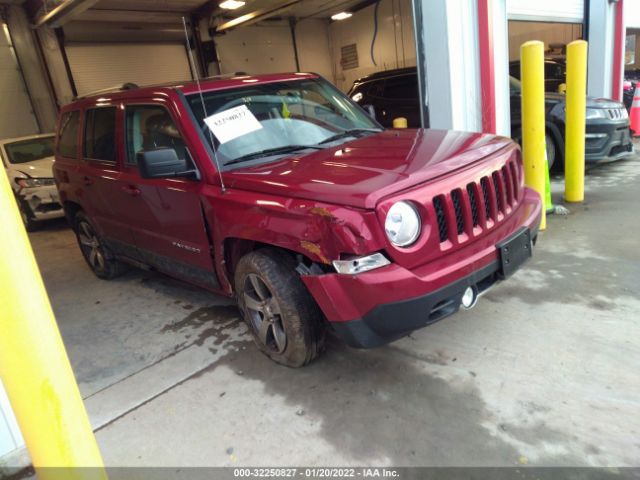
564;40;587;202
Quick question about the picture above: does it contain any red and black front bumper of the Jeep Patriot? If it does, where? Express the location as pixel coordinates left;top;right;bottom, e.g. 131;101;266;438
302;186;542;348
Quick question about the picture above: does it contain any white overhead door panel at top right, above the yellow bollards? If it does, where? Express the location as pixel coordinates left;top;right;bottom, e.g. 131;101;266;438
507;0;584;23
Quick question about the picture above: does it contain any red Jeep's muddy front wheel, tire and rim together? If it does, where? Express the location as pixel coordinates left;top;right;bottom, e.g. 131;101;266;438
234;249;325;367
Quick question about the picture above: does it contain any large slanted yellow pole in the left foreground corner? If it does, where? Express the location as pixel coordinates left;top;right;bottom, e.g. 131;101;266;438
0;168;107;480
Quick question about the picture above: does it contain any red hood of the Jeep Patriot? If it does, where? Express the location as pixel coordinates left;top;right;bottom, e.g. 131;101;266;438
223;129;515;209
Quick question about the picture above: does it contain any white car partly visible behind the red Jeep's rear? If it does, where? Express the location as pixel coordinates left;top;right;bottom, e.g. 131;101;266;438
0;134;64;230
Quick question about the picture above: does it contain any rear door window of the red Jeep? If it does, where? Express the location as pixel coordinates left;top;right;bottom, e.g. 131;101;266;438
84;107;116;162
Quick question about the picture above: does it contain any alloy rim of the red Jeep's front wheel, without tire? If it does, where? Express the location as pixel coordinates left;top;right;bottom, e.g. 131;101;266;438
242;273;287;353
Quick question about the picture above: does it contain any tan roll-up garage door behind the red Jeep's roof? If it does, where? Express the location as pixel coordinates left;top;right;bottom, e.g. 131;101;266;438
65;43;191;95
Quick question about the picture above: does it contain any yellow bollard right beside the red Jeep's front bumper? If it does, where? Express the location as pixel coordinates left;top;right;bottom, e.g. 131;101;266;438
520;41;547;230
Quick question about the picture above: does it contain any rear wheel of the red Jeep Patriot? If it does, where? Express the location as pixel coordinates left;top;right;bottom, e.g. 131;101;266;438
73;212;127;280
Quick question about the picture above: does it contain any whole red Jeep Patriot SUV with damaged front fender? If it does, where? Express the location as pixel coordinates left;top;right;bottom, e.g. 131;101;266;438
54;73;541;366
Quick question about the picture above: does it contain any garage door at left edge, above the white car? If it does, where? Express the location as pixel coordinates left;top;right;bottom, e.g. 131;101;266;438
0;23;39;139
